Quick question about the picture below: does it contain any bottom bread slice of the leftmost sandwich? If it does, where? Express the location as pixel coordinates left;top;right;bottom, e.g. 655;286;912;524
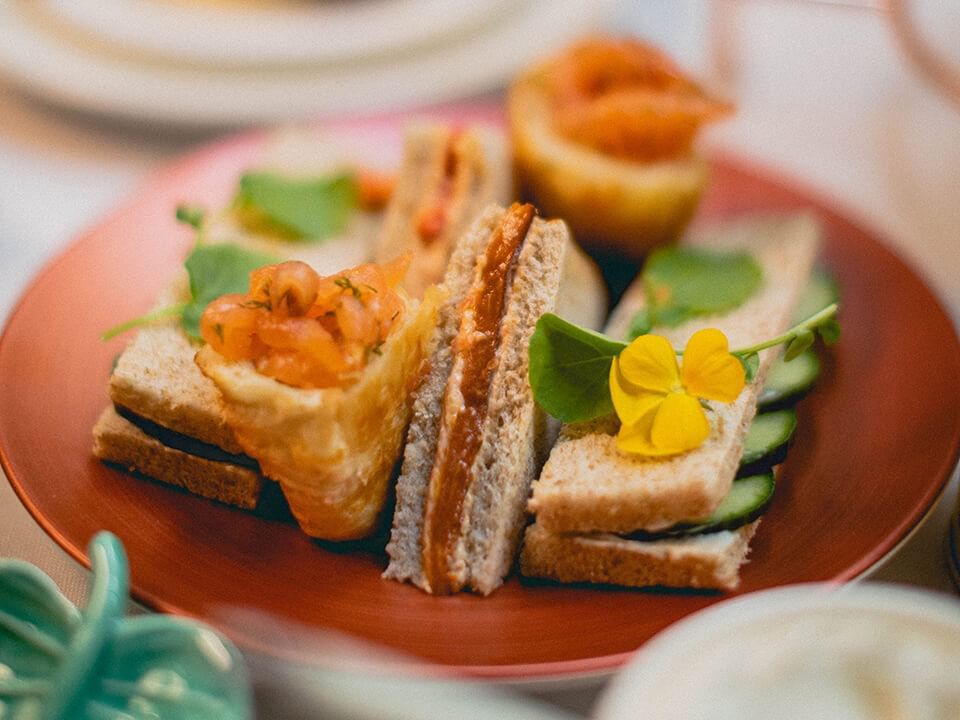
93;406;265;510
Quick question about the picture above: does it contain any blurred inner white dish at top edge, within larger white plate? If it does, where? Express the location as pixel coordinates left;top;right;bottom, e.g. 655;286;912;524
35;0;513;67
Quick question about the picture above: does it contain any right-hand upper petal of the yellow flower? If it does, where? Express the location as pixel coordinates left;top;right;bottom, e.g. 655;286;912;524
681;328;746;402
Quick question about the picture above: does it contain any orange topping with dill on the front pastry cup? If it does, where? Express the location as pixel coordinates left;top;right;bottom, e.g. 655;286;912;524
200;253;410;388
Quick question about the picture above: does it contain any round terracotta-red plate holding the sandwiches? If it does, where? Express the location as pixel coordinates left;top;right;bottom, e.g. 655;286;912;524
0;107;960;679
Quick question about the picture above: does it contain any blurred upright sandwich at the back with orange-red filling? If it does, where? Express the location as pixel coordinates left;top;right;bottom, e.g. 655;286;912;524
374;123;513;298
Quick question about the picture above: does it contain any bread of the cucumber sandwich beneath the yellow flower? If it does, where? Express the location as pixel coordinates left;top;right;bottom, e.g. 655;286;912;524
521;216;819;589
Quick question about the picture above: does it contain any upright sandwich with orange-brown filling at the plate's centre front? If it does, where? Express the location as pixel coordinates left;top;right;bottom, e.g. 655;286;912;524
384;204;606;595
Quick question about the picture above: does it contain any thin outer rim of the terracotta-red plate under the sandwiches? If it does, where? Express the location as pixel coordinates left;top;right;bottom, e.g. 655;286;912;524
0;103;960;685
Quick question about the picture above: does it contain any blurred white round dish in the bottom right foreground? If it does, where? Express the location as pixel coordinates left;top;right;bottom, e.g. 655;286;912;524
597;583;960;720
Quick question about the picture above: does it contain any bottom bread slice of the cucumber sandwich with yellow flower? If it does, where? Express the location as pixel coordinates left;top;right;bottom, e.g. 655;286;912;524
520;520;760;590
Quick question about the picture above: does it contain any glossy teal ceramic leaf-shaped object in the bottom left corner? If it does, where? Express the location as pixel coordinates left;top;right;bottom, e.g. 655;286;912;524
0;533;251;720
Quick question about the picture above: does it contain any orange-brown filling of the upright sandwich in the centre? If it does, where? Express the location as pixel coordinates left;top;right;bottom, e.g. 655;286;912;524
421;203;535;594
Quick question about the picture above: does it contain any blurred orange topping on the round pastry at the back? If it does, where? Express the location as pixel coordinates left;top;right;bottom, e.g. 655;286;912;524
546;38;733;162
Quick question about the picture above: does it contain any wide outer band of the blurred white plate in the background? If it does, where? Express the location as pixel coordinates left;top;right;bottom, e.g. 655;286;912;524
0;0;609;127
